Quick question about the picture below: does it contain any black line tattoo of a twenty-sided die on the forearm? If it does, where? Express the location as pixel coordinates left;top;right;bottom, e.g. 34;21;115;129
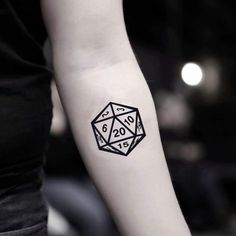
91;102;146;156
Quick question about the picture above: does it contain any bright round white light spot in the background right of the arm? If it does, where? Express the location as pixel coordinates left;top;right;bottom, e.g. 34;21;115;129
181;63;203;86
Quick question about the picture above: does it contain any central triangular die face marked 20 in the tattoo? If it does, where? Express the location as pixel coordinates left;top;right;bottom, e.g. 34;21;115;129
109;119;134;143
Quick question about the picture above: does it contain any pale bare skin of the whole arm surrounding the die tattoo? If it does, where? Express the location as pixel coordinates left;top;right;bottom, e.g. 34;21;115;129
41;0;190;236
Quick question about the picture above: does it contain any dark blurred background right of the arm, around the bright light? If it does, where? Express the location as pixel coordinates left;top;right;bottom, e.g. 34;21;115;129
124;0;236;235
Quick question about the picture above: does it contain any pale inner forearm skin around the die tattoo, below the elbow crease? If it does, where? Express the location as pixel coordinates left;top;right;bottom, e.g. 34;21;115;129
54;56;189;236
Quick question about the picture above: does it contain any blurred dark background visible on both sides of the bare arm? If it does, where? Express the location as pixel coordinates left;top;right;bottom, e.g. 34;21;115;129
44;0;236;236
